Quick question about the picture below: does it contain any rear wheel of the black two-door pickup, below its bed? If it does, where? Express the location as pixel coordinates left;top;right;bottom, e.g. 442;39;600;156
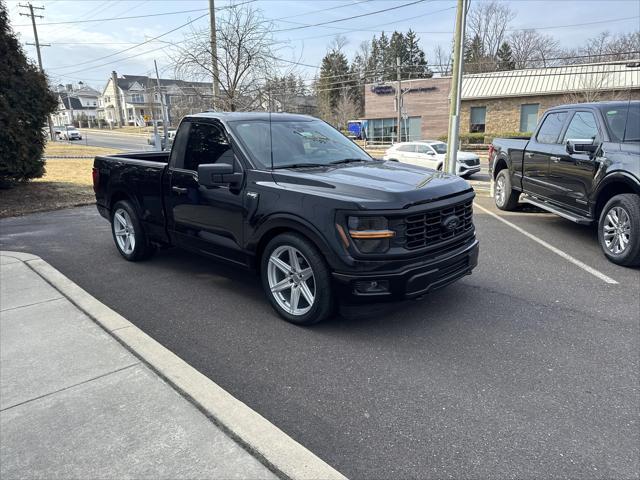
111;200;155;262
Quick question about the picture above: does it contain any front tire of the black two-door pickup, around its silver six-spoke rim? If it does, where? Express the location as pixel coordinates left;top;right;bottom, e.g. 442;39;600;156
260;233;335;325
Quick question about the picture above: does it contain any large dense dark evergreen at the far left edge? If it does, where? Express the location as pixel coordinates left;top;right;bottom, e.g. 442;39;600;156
0;1;57;187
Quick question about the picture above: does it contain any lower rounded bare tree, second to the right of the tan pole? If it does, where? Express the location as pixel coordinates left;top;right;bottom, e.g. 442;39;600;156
509;30;561;68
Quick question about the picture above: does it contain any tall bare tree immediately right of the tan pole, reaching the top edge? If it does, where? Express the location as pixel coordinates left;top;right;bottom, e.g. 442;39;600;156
467;0;516;58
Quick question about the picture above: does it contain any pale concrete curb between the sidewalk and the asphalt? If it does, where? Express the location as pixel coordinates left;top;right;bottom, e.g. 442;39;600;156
0;251;346;480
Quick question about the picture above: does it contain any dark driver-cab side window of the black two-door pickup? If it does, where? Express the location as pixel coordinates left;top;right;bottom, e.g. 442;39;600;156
183;123;234;171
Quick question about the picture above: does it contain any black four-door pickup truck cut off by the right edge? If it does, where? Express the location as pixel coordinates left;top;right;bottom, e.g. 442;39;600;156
489;101;640;266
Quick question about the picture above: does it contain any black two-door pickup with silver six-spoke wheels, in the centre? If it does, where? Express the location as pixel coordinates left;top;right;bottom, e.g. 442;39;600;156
93;113;478;324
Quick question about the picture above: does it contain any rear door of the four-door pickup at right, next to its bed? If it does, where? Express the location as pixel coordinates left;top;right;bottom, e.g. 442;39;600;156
522;112;567;198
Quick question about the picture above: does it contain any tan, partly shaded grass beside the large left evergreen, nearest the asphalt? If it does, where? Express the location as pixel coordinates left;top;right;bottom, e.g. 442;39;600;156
0;158;95;218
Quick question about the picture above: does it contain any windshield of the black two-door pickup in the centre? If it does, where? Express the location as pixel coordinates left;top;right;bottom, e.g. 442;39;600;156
229;120;372;168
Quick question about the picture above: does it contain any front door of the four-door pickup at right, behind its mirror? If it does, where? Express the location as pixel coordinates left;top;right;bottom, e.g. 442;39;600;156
549;110;602;213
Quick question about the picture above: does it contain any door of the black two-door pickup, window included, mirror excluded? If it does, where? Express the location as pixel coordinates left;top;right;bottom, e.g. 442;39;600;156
165;120;246;264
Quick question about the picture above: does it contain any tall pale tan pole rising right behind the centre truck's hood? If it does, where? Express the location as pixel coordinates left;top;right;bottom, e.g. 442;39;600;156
445;0;468;175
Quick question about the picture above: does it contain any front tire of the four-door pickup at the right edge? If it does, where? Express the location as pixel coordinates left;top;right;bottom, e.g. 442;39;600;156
598;193;640;267
